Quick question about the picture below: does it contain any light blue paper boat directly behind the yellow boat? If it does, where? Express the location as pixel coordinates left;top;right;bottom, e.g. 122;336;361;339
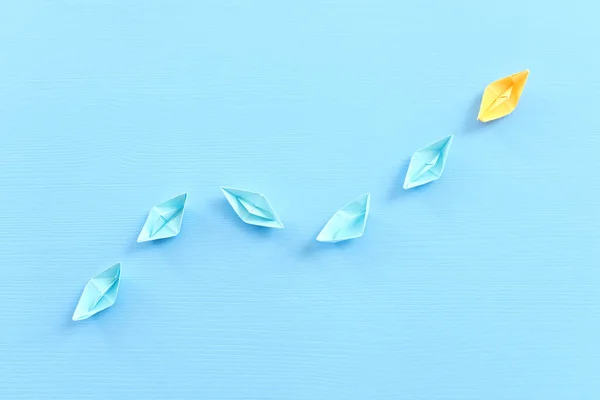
404;135;454;189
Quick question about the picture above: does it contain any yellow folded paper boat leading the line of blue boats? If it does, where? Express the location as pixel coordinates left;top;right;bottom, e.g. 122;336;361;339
477;69;529;122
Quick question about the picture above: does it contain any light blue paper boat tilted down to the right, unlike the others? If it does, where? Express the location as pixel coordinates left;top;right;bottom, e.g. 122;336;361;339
221;186;283;228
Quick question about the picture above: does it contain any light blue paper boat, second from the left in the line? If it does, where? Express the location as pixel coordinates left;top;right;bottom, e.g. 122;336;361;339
138;193;187;243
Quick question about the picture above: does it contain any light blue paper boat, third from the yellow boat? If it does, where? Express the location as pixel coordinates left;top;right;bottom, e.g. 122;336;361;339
317;193;371;243
